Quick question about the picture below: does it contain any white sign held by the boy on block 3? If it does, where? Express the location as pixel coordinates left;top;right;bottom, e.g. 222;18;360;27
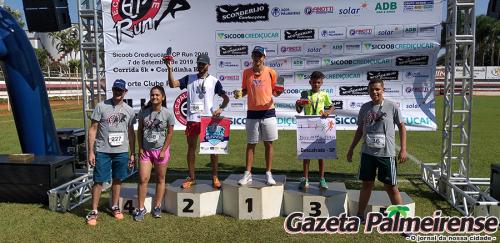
296;116;337;159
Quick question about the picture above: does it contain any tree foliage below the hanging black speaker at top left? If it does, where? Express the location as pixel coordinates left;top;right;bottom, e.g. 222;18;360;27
49;26;80;59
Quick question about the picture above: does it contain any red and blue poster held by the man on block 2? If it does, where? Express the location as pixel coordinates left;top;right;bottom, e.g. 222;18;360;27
200;116;231;154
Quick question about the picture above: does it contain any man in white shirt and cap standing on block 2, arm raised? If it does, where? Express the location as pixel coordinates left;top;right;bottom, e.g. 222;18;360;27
166;54;229;189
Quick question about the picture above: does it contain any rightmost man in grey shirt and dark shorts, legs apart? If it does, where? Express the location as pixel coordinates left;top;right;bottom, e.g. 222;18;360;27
347;79;406;221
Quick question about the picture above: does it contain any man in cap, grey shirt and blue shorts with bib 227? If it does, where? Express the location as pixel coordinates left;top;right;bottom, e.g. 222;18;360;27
86;79;135;225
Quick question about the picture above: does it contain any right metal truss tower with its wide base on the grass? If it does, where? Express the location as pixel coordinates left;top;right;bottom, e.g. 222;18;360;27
421;0;499;215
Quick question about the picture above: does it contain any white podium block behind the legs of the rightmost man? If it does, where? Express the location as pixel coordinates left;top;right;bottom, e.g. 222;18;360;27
347;190;415;217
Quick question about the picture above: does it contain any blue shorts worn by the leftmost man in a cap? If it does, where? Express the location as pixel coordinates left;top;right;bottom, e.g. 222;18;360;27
94;152;129;183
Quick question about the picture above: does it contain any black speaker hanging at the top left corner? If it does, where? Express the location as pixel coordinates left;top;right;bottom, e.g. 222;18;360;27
23;0;71;32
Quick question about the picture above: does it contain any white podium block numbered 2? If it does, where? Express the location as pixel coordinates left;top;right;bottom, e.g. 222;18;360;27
163;179;222;217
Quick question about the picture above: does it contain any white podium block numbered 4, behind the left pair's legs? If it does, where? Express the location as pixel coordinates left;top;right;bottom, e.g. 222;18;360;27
114;185;154;214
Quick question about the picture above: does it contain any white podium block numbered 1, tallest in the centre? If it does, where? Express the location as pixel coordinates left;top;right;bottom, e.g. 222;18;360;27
222;174;286;219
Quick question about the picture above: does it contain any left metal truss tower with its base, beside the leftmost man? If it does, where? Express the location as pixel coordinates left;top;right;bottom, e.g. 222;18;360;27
48;0;109;211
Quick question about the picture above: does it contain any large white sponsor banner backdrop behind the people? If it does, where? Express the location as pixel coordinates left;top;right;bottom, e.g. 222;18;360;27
101;0;442;130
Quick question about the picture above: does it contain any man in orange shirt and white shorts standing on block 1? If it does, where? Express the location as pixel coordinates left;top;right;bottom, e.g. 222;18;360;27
235;46;283;185
